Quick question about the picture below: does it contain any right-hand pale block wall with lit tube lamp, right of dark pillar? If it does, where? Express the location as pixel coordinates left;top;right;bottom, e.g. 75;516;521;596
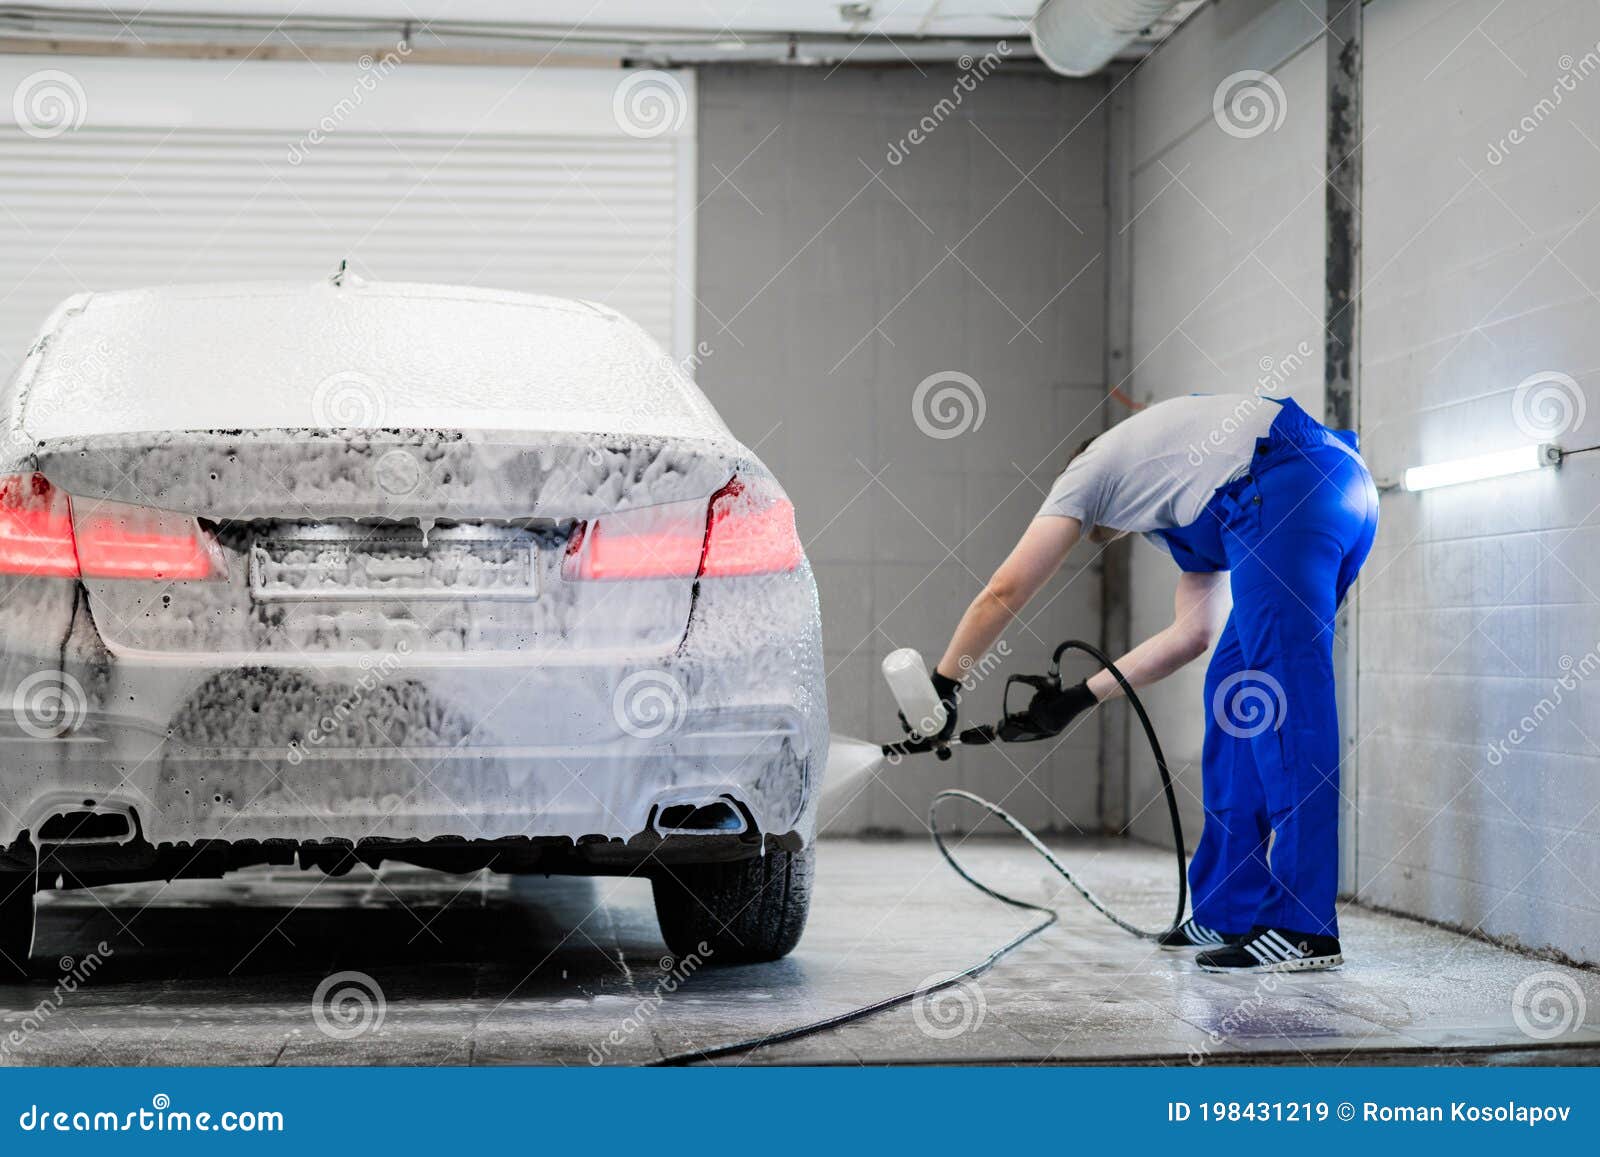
1358;0;1600;962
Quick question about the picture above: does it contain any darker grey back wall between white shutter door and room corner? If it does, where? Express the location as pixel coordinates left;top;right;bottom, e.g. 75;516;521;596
696;67;1106;832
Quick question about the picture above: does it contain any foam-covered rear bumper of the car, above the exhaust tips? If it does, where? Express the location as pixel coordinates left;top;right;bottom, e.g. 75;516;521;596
0;656;827;848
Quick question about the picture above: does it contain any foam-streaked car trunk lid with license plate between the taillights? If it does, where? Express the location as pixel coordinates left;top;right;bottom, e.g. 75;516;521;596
35;430;738;664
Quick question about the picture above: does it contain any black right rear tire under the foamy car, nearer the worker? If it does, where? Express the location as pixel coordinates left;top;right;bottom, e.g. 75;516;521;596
653;848;816;963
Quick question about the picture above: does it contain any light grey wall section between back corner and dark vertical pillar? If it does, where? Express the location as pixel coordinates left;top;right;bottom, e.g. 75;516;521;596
1118;0;1326;845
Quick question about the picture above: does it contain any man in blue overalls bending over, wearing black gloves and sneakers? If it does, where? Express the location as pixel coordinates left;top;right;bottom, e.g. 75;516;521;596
933;394;1378;971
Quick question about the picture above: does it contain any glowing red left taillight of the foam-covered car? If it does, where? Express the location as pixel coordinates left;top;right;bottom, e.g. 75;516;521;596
0;474;227;581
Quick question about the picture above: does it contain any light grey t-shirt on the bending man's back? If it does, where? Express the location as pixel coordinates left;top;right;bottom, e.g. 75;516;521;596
1038;394;1280;549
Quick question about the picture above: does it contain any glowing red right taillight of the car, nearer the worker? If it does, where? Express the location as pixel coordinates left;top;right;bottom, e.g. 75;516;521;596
562;478;803;581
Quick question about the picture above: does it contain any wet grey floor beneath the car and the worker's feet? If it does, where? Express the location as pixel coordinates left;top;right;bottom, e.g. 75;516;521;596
0;840;1600;1066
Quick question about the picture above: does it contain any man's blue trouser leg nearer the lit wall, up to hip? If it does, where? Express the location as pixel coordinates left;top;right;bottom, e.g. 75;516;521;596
1226;450;1373;936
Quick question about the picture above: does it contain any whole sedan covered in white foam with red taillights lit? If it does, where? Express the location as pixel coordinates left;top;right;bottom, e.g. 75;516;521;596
0;277;827;971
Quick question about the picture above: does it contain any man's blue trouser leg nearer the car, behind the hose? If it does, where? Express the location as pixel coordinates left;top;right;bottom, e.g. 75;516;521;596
1189;618;1269;936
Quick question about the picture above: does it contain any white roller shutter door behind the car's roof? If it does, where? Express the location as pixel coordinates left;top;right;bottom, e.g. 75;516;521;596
0;56;694;373
